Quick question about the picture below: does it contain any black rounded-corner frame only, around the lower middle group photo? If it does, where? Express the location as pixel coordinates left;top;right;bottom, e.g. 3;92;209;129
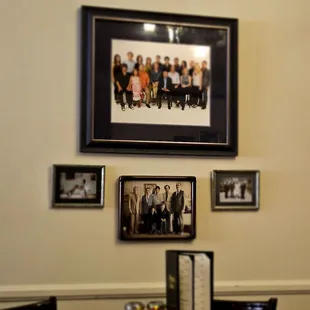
117;175;197;242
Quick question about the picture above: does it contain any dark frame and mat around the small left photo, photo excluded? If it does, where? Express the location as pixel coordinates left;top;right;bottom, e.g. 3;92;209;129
52;165;106;209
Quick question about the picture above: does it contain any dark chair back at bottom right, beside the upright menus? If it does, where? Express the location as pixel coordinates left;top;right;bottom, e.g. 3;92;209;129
213;298;278;310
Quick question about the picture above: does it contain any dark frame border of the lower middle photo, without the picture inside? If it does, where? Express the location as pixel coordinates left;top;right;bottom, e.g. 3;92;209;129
118;175;196;242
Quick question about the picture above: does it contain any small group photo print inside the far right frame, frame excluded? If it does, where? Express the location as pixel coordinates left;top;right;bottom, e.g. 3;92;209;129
220;178;252;203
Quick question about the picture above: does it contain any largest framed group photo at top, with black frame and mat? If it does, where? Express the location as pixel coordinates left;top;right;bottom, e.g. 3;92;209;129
80;6;238;157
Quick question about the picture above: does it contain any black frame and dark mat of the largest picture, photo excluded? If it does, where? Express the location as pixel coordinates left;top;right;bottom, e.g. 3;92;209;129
80;6;238;157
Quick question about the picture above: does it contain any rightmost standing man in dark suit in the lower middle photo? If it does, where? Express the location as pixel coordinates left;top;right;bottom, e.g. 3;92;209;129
171;183;185;234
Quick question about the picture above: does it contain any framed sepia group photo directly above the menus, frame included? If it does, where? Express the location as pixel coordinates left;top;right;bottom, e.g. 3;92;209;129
118;176;196;241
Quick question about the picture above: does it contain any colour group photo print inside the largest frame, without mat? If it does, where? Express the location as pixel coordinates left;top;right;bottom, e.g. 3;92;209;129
111;39;211;126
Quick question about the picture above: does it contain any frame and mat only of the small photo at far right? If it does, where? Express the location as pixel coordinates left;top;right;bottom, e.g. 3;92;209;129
211;170;260;211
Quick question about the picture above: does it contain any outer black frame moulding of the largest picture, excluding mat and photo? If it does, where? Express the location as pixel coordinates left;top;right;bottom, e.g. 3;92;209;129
80;6;238;157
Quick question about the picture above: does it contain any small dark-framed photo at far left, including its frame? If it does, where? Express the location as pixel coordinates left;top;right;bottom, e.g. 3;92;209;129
52;165;105;208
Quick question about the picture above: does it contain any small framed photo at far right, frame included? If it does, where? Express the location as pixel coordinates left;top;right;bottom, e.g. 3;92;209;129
211;170;260;211
